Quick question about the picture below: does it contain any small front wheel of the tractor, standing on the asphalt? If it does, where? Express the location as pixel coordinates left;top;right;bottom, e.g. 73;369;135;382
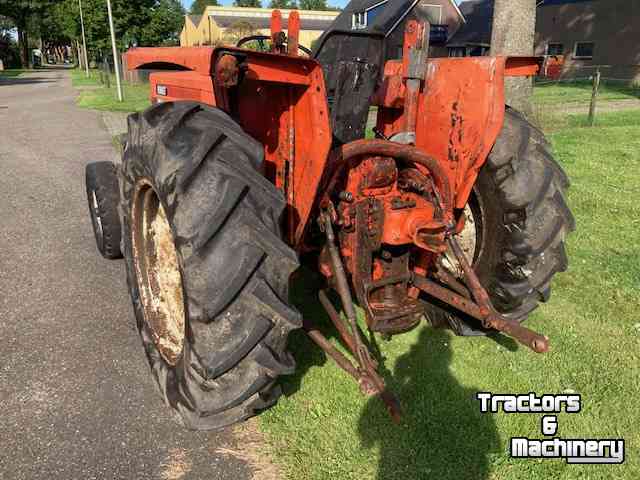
85;162;122;259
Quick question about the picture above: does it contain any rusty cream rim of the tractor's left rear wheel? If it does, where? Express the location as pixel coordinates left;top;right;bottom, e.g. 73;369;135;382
131;180;185;366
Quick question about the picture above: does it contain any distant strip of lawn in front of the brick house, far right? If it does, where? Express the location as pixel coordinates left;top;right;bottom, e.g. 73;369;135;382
533;81;640;105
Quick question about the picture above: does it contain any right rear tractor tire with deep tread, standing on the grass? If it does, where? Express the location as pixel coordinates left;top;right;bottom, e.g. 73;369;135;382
427;108;575;335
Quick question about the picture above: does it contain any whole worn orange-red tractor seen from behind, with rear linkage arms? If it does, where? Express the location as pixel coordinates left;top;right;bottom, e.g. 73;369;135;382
87;11;574;429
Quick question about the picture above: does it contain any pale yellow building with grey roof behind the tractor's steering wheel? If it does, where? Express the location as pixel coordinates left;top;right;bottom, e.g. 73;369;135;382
180;6;339;48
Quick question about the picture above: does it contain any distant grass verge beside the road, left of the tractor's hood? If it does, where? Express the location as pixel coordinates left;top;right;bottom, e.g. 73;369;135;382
71;69;151;112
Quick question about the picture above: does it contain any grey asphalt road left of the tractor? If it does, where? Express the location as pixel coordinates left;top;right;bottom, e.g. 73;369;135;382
0;70;253;480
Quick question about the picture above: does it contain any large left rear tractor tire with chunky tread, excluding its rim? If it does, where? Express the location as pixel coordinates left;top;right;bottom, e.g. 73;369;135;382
120;102;302;430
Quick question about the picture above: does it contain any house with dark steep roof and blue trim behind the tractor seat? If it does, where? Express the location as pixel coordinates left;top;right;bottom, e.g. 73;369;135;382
332;0;465;59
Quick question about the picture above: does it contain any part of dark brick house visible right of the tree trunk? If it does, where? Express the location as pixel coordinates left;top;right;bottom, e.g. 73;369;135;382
535;0;640;82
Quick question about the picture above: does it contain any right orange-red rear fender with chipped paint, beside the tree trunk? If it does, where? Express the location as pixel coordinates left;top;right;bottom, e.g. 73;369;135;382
374;57;541;208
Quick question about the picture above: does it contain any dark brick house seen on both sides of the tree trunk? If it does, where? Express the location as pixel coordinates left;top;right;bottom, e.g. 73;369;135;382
447;0;640;82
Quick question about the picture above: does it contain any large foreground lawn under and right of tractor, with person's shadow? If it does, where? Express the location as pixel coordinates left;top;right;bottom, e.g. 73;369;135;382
260;111;640;480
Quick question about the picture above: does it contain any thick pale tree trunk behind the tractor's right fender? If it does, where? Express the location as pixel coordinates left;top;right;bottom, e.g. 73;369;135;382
491;0;537;117
